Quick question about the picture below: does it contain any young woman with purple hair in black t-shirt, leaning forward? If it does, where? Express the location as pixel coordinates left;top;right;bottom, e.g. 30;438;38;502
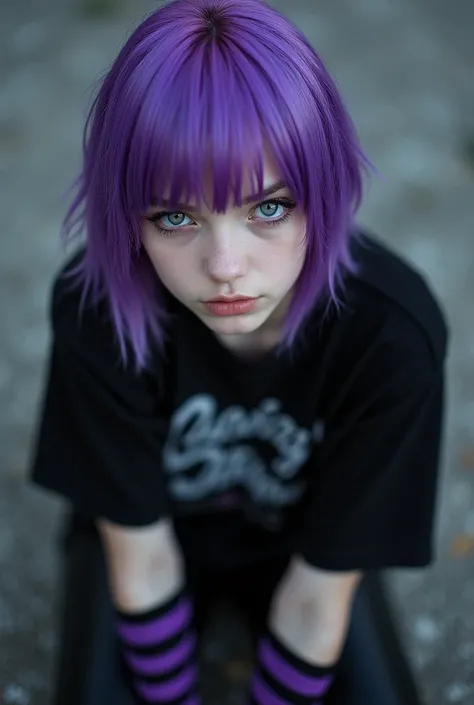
33;0;446;705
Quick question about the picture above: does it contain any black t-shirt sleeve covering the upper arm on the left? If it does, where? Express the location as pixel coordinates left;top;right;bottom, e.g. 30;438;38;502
31;278;167;526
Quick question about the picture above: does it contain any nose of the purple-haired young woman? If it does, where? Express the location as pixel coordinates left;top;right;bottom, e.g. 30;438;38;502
205;231;247;284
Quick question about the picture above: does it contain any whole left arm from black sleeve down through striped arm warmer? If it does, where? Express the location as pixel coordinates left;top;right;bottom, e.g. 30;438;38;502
32;262;198;705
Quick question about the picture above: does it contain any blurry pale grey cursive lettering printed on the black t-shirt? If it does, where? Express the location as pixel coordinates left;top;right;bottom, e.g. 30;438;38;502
163;394;322;507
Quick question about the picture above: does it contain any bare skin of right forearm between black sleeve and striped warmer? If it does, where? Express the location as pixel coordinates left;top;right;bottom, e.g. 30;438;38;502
269;557;362;666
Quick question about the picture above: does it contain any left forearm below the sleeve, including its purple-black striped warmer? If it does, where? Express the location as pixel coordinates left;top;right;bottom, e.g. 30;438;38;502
97;519;199;705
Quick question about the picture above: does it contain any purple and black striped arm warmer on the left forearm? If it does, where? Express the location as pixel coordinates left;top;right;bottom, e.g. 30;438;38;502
116;593;201;705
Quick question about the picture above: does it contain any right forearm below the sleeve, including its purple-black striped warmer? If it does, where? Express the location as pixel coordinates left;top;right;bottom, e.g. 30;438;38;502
250;556;361;705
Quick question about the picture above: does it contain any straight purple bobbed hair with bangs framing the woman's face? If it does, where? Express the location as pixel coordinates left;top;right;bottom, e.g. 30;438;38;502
64;0;368;368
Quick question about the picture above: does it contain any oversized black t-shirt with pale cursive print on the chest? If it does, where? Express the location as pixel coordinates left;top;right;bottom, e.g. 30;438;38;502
32;237;447;570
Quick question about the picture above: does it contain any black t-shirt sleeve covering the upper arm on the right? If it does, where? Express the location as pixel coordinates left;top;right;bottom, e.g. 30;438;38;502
300;316;444;571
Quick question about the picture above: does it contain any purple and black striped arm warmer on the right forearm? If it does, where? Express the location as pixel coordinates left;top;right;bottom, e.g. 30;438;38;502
250;634;335;705
